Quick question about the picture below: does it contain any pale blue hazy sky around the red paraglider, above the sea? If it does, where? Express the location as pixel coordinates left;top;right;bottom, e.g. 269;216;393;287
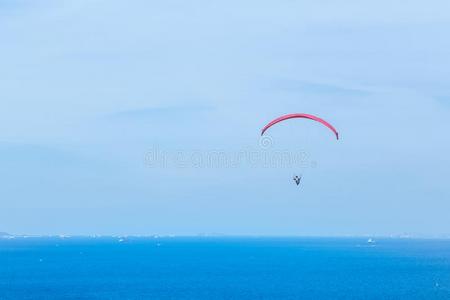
0;0;450;237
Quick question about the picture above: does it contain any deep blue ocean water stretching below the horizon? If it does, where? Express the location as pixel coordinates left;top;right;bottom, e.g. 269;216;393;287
0;238;450;300
